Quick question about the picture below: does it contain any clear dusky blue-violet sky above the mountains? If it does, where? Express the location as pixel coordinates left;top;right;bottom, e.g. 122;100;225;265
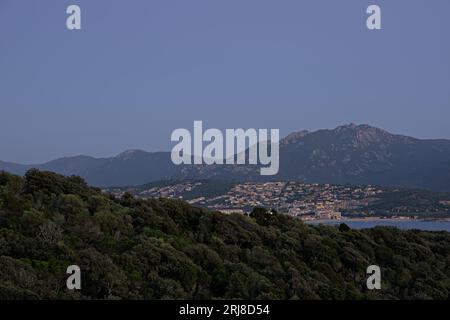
0;0;450;164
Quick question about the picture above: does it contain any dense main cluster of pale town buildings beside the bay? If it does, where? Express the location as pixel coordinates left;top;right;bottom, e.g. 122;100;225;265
202;182;383;220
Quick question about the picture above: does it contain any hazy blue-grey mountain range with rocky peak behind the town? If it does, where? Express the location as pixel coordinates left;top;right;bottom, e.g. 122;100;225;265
0;124;450;191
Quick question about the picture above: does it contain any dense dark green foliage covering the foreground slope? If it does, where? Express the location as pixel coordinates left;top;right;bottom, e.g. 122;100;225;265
0;170;450;299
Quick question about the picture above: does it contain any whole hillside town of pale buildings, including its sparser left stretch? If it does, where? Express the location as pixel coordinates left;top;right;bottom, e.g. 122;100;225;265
107;182;383;220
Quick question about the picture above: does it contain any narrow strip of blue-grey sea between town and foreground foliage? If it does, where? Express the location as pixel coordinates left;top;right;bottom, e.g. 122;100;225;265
307;219;450;232
